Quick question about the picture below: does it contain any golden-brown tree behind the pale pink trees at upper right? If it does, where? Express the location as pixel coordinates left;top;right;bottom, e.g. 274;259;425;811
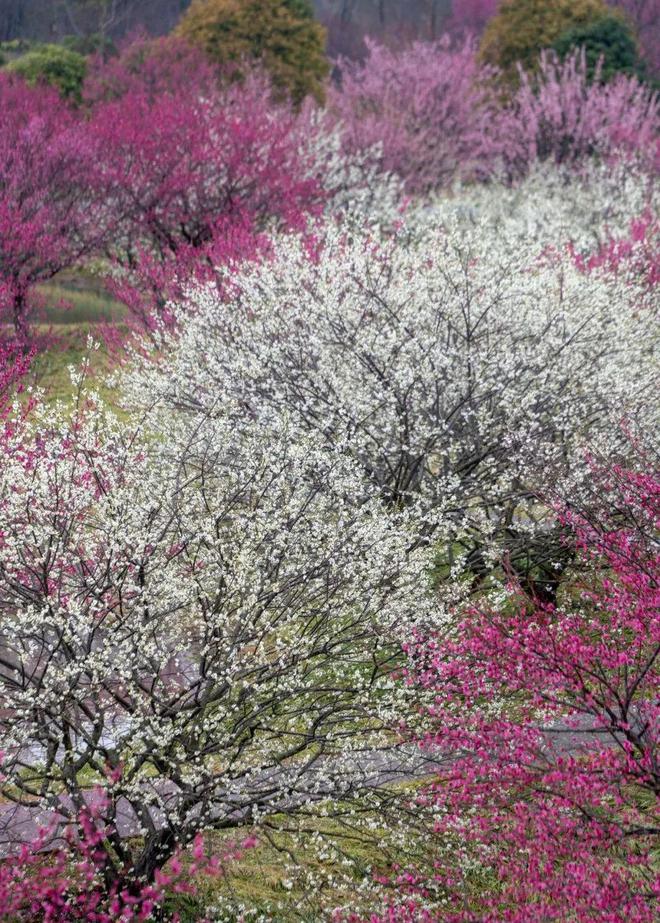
480;0;611;81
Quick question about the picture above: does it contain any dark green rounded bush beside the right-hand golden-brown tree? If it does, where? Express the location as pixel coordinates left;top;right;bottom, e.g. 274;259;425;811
553;14;646;82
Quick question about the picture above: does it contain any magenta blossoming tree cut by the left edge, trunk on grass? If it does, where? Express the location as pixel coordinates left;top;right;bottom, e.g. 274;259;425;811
0;74;109;341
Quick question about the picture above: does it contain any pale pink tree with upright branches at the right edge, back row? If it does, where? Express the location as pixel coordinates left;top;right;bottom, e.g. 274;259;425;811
498;53;660;177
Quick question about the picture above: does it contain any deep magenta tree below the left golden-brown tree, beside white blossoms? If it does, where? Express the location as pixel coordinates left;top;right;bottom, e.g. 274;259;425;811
91;66;325;320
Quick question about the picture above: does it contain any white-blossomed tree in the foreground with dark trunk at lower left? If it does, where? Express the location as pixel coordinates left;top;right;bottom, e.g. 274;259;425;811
0;374;442;887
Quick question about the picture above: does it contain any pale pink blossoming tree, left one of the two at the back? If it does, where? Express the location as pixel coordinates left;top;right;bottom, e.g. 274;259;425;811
328;37;498;193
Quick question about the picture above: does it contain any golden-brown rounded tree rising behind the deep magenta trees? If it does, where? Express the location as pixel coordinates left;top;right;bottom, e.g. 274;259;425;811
176;0;329;103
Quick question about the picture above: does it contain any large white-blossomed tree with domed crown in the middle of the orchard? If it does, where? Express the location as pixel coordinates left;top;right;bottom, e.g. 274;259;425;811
131;220;657;581
